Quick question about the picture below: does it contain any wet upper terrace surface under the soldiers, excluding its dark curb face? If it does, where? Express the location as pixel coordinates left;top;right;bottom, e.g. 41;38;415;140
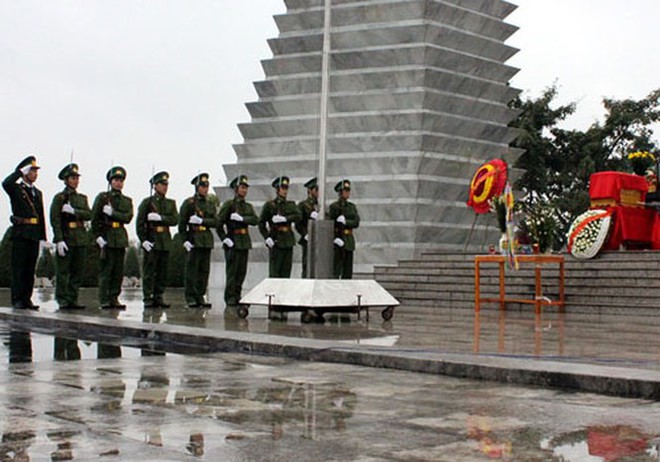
0;289;660;369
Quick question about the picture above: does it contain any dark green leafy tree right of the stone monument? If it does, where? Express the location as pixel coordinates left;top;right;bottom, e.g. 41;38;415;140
510;86;660;248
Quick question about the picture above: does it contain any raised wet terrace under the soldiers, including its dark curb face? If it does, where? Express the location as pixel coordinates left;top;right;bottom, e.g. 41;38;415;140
0;291;660;399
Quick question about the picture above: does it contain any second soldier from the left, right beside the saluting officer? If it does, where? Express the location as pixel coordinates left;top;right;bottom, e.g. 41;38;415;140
50;164;92;309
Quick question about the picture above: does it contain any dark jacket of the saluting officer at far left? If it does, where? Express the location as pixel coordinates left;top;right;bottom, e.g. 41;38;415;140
2;169;46;241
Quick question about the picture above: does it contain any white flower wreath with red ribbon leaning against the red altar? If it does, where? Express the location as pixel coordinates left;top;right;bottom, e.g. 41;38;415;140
568;209;611;259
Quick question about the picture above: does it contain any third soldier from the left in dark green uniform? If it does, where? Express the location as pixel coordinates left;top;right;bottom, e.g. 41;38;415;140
92;166;133;310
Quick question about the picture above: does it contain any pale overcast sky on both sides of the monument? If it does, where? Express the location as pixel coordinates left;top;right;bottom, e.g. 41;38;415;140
0;0;660;235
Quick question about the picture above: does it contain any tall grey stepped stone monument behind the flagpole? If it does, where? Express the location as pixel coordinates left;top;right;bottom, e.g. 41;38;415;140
219;0;520;272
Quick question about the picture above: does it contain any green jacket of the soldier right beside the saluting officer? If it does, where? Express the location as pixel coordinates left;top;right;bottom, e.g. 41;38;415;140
50;186;92;247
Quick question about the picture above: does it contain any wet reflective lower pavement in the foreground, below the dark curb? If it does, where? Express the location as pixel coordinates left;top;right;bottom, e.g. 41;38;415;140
0;334;660;461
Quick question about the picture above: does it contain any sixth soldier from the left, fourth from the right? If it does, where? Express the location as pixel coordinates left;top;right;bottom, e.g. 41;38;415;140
218;175;259;306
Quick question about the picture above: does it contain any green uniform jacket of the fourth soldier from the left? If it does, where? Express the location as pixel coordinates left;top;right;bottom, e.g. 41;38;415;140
135;193;179;252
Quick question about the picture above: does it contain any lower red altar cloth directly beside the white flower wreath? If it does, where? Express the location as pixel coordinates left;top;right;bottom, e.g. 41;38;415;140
603;206;660;250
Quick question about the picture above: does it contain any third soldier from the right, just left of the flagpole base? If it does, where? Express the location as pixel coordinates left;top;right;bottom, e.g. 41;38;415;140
259;176;302;278
